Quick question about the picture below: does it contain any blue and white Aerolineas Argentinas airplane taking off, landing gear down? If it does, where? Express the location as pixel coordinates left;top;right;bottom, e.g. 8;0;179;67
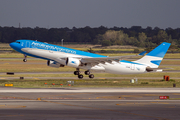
9;40;171;79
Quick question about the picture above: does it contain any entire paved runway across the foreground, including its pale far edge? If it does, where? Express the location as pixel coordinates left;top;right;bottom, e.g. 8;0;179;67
0;87;180;120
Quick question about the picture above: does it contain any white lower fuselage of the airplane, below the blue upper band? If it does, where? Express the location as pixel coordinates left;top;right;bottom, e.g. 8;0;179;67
21;48;147;74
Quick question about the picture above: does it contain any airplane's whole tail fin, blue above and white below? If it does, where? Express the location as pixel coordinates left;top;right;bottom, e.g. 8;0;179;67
134;42;171;68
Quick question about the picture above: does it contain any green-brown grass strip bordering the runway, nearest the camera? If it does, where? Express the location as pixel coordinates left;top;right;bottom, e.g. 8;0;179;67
0;79;180;88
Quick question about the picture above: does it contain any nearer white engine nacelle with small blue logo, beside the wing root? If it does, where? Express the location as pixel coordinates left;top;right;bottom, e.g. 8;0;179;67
66;58;81;68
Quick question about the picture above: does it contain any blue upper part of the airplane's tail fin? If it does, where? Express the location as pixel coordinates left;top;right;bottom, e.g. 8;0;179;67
147;42;171;58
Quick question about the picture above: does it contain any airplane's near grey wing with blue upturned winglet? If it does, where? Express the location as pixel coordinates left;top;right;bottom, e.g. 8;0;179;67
81;51;146;64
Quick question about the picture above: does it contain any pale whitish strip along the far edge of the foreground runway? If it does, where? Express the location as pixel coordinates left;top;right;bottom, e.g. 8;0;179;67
0;87;180;93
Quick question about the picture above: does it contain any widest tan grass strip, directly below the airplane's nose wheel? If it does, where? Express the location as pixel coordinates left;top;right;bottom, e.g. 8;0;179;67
0;59;180;72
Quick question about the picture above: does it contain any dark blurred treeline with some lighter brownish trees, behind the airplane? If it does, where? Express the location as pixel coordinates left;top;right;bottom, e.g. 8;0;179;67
0;26;180;49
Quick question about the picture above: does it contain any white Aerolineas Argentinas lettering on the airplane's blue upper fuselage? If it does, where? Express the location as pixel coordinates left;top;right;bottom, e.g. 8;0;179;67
31;42;76;54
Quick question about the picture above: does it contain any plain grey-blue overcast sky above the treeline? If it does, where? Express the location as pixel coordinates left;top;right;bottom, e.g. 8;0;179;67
0;0;180;29
